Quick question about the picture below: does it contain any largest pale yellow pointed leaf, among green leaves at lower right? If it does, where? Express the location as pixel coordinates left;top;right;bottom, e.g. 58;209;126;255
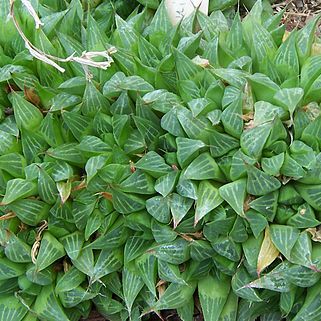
256;227;279;275
